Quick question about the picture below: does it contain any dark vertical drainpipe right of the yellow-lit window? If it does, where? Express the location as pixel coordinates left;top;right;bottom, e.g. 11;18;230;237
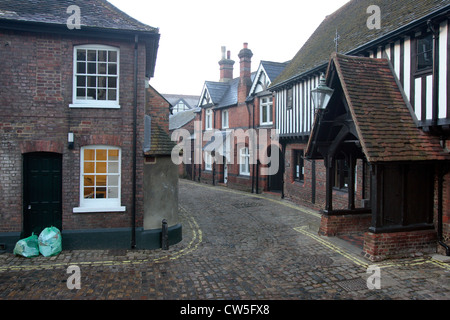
131;35;139;249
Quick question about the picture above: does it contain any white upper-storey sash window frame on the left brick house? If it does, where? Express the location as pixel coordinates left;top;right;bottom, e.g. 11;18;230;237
69;44;120;109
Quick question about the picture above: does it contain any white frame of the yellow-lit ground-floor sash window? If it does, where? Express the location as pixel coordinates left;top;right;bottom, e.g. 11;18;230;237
73;145;126;213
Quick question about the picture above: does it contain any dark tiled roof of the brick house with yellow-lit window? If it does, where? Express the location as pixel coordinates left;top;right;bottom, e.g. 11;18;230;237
0;0;158;33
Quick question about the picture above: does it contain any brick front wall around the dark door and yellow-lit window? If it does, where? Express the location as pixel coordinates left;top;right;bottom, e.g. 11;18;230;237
0;31;145;232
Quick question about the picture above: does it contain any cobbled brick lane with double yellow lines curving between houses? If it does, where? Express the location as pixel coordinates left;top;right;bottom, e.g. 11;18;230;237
0;180;450;300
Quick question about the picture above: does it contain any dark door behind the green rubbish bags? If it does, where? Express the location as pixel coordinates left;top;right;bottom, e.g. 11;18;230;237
23;152;62;236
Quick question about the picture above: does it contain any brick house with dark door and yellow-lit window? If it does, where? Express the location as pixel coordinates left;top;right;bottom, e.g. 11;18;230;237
0;0;181;251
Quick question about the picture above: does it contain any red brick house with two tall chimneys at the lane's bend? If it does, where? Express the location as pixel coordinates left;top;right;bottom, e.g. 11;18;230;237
194;43;285;192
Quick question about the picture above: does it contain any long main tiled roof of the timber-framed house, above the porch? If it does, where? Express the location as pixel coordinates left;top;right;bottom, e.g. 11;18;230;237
271;0;450;88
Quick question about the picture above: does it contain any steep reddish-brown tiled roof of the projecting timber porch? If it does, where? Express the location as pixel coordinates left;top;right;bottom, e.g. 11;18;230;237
331;54;450;162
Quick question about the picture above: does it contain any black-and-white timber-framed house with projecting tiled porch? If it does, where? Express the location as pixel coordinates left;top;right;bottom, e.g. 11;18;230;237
270;0;450;260
